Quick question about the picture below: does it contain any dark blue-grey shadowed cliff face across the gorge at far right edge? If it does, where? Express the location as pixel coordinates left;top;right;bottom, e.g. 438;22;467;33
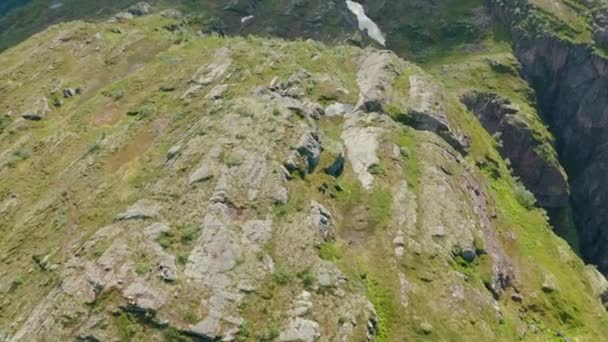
491;1;608;273
